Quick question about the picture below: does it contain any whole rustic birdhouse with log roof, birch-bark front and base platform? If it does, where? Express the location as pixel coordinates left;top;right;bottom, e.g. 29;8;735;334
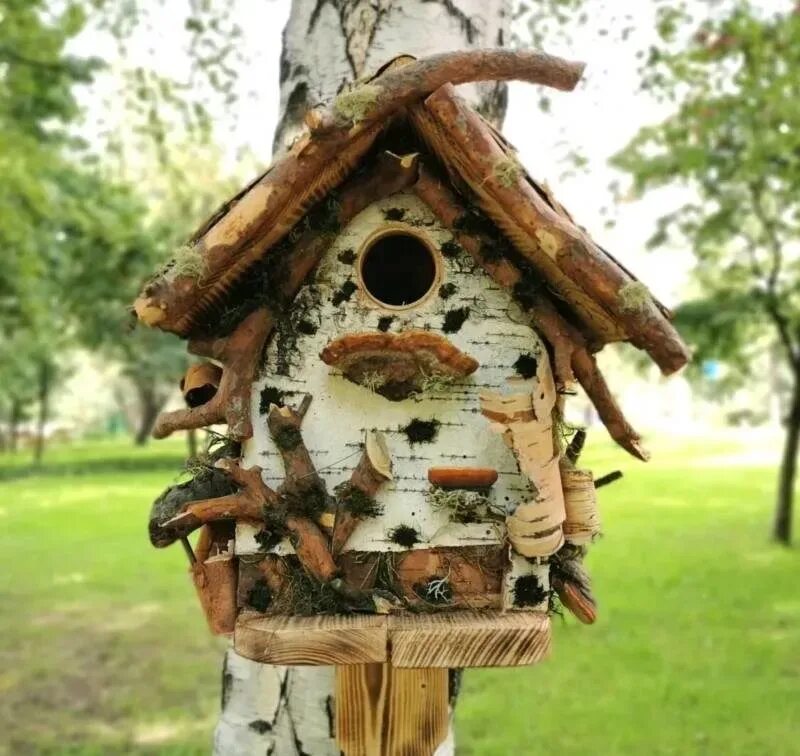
135;51;687;752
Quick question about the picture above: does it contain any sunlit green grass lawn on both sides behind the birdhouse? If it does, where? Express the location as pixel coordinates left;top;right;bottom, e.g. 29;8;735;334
0;432;800;756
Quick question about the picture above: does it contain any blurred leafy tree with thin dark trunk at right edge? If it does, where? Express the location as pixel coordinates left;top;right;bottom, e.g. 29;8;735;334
616;0;800;543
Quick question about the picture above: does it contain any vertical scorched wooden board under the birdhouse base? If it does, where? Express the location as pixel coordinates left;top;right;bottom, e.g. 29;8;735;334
336;664;448;756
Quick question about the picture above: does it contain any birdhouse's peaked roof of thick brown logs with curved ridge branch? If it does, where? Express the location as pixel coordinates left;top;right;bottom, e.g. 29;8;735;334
135;51;688;380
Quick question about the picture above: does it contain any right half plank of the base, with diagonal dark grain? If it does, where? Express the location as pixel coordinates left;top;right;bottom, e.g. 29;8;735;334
389;611;550;667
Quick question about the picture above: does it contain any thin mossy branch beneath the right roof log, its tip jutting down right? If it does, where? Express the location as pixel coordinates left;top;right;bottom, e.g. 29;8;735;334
414;167;648;460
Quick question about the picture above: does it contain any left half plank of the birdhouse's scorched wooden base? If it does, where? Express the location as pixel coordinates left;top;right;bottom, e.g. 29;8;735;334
233;613;388;665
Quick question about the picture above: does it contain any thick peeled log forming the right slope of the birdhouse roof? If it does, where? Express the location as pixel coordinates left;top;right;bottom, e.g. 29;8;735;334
409;85;689;374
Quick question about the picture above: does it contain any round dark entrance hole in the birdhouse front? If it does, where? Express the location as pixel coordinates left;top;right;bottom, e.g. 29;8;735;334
361;232;436;307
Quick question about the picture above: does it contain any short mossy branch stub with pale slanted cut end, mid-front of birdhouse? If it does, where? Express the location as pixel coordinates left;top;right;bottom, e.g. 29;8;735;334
331;431;392;556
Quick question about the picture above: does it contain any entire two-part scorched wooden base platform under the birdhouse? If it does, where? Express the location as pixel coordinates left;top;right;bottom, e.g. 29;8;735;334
233;610;550;668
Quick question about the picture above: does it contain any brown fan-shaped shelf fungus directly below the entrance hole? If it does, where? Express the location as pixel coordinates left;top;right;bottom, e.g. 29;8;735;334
320;330;478;400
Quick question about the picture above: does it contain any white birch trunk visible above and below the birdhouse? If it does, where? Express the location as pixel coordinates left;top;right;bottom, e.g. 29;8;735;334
214;0;511;756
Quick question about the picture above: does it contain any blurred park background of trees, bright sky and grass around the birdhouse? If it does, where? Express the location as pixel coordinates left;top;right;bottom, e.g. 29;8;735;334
0;0;800;755
